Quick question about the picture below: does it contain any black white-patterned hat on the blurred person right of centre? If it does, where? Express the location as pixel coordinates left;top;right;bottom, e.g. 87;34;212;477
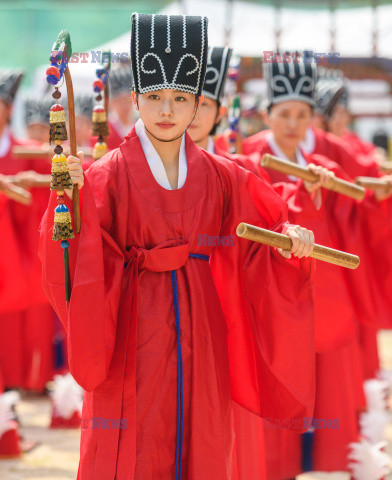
263;58;317;107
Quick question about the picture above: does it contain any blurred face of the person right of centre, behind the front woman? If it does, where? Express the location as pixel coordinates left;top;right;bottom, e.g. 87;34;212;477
264;100;312;148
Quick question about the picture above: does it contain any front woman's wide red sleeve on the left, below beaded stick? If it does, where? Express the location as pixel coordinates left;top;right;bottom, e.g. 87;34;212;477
40;154;126;391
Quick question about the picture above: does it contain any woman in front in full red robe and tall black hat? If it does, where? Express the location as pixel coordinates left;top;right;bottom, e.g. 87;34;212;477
41;14;314;480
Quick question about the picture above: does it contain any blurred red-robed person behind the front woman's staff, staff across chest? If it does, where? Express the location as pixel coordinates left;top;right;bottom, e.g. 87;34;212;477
230;59;392;479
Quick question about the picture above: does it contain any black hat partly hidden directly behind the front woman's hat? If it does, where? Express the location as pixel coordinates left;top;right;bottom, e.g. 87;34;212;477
203;47;233;102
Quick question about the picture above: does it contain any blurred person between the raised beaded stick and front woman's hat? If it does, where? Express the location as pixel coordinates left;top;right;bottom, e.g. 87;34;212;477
106;64;136;151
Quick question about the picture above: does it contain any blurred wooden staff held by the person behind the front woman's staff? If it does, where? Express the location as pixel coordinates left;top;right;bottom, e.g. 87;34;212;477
261;153;365;200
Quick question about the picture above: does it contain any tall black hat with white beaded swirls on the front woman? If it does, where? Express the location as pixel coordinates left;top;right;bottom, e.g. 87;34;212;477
131;13;208;95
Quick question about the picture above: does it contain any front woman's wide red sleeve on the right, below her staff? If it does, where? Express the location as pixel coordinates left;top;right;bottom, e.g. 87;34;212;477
211;159;315;430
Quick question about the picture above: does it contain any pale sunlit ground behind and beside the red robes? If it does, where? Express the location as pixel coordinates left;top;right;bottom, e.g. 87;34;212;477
0;331;392;480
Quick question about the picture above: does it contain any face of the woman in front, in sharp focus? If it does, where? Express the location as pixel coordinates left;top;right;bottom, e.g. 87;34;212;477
132;89;203;140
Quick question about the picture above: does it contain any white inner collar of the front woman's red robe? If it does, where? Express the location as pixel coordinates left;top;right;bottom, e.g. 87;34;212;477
135;118;187;190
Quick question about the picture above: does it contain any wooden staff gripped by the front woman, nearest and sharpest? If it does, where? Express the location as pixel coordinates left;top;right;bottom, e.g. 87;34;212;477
236;223;359;270
